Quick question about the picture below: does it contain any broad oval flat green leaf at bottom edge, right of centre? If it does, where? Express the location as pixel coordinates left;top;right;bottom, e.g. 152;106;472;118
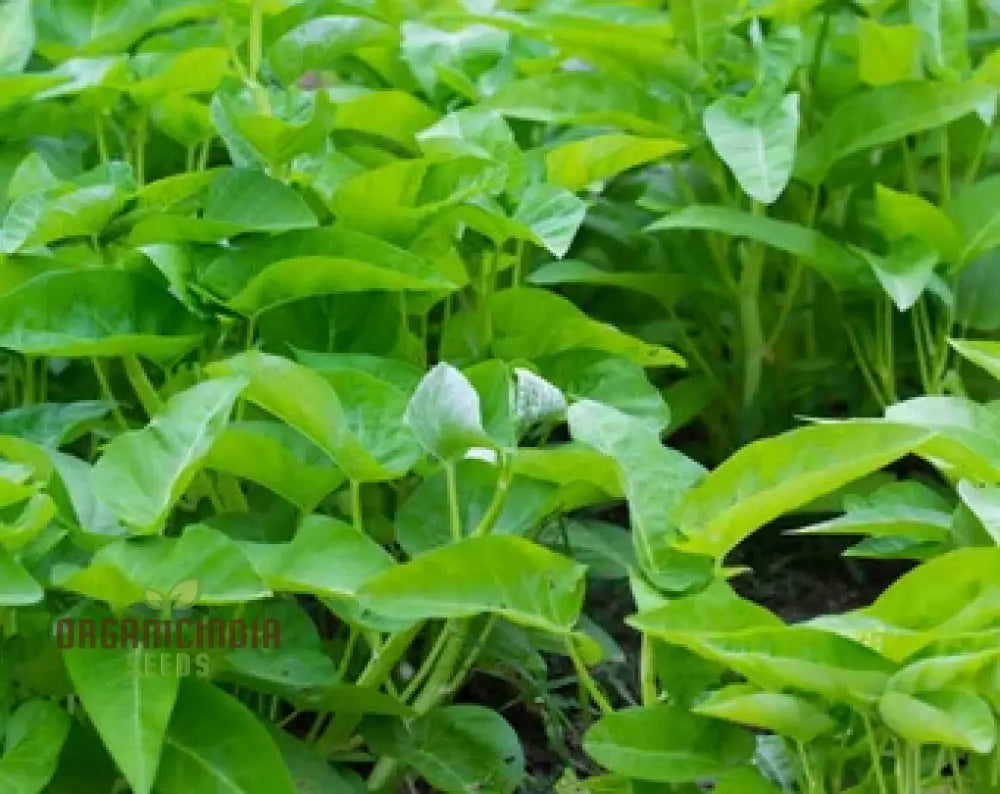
583;705;754;783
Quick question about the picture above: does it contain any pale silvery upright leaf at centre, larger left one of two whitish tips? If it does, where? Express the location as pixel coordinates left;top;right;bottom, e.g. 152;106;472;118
405;363;493;462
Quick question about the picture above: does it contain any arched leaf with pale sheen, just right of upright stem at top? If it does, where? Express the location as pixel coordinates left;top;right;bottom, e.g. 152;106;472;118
267;16;399;83
